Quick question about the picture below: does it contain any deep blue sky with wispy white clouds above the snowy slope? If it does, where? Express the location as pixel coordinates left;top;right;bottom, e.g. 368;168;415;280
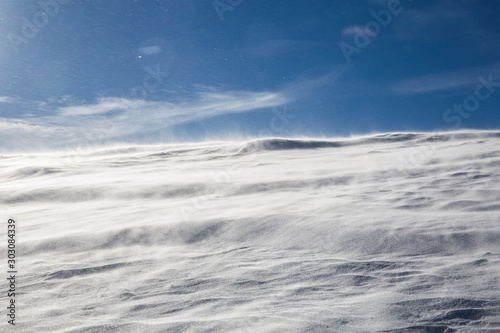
0;0;500;151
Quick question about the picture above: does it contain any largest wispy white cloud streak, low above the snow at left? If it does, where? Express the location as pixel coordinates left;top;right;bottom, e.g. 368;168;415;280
0;91;289;150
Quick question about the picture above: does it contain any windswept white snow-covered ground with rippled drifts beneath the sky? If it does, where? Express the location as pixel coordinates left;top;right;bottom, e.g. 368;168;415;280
0;131;500;333
